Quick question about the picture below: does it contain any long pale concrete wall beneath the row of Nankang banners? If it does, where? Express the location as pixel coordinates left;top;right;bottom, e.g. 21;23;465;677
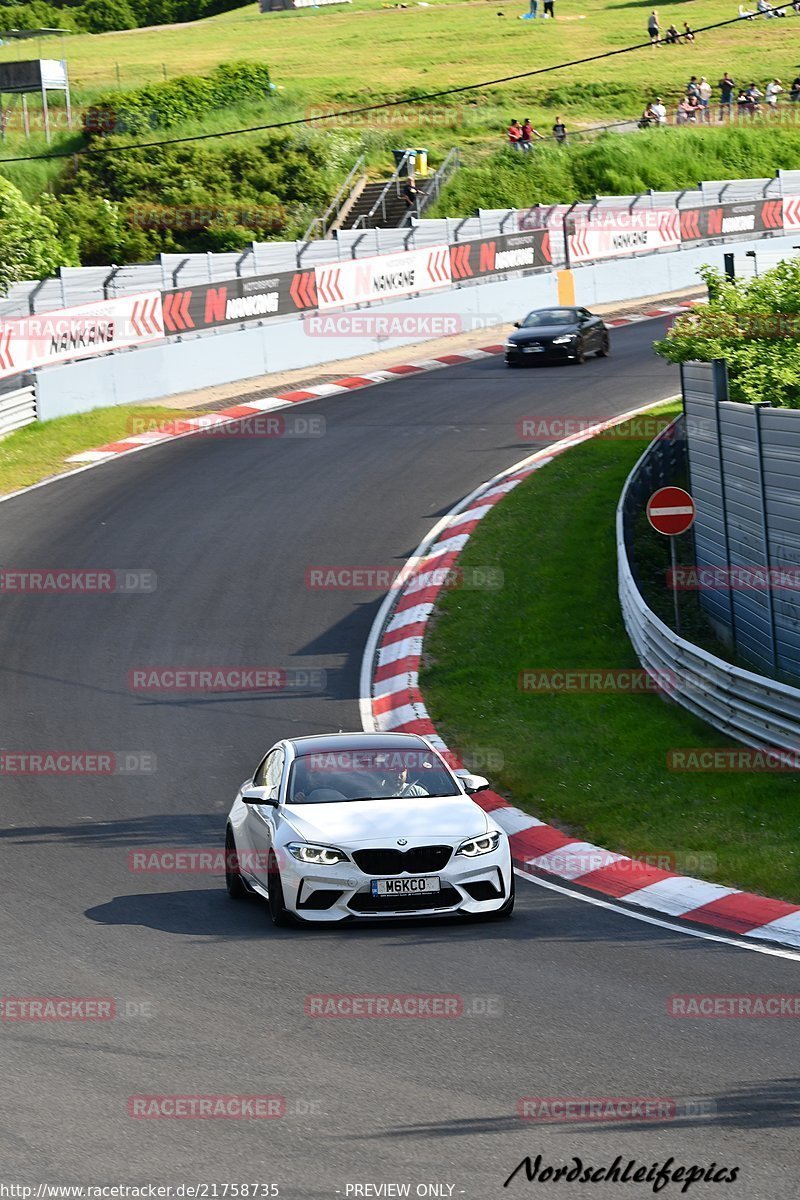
36;235;798;421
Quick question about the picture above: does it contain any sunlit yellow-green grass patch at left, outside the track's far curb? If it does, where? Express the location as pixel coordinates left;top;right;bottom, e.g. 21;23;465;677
0;404;204;496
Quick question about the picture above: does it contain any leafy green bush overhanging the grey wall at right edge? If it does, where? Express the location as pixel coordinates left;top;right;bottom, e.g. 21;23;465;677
656;258;800;408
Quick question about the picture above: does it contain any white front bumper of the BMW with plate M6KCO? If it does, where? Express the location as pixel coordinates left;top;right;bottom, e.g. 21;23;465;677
275;838;512;923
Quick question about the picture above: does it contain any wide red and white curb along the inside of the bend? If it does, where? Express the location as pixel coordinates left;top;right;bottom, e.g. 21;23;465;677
361;406;800;949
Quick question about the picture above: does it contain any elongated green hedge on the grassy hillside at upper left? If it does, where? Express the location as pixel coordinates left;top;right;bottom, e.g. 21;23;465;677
83;62;272;137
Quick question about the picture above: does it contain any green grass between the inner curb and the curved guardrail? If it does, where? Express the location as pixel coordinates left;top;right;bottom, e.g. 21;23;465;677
421;408;800;901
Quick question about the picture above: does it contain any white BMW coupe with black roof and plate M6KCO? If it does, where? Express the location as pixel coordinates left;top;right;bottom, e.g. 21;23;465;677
225;733;515;925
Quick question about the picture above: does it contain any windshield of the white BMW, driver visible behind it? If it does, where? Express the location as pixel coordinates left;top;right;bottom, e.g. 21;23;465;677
287;746;461;804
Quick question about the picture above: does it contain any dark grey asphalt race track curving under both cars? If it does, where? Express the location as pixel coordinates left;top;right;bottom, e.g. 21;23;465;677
0;322;800;1200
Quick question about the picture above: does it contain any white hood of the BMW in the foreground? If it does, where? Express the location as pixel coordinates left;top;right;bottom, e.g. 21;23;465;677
283;796;489;847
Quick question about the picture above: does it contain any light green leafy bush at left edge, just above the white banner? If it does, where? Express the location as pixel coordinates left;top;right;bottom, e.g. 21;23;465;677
0;179;78;294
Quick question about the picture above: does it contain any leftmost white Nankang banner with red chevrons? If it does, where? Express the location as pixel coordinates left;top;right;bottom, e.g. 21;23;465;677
0;292;164;378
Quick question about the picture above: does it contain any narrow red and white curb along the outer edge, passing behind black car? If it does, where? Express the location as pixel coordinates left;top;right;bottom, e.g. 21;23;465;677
66;300;696;463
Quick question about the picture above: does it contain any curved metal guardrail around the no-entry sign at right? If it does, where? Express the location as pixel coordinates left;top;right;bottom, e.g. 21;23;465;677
616;416;800;761
